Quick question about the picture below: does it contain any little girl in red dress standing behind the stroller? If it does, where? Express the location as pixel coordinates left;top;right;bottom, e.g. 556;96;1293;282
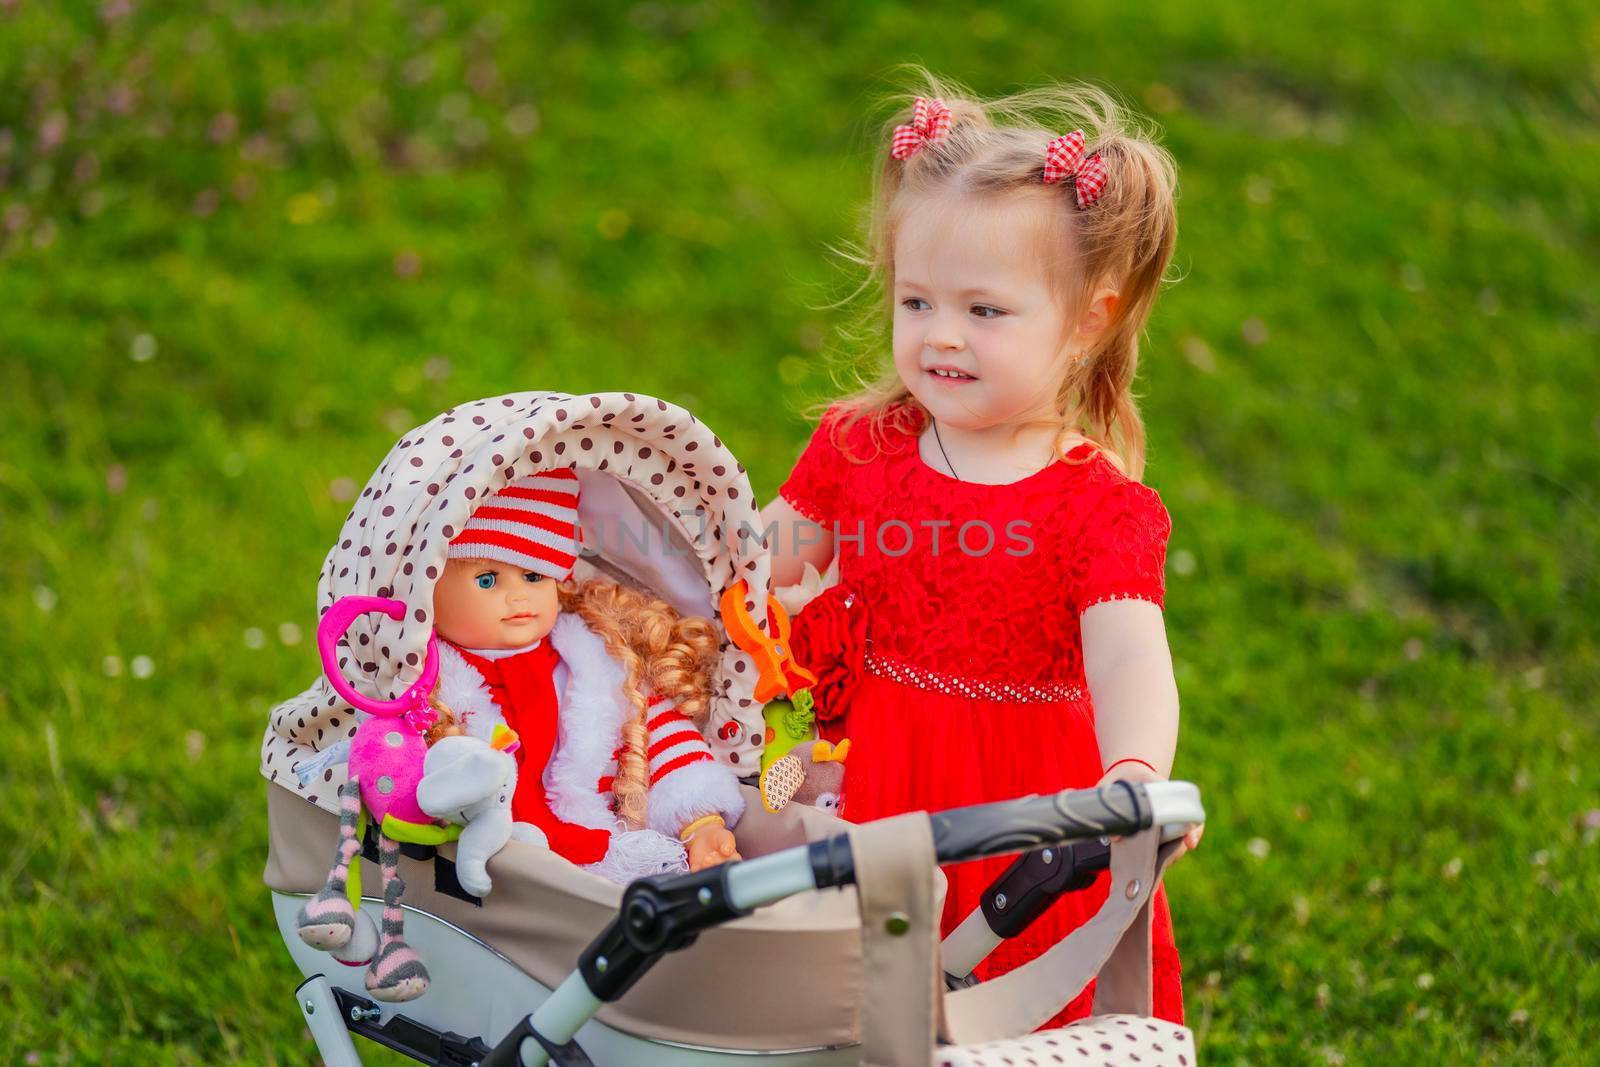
762;82;1198;1025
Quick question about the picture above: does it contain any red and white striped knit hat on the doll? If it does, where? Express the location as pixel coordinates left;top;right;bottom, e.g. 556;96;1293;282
446;469;579;582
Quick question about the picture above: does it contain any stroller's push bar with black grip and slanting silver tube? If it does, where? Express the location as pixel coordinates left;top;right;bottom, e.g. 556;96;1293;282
483;782;1205;1067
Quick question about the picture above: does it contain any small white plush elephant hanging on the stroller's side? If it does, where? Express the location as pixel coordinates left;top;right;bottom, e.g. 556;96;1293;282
416;736;547;896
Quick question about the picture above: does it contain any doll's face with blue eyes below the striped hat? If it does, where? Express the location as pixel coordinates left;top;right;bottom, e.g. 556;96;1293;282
434;560;562;648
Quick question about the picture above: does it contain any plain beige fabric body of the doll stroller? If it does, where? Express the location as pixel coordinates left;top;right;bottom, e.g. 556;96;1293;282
264;785;896;1051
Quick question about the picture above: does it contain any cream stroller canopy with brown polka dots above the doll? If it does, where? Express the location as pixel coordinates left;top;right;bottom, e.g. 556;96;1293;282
261;392;768;811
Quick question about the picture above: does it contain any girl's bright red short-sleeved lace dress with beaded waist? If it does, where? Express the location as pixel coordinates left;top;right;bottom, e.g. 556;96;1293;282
781;399;1184;1025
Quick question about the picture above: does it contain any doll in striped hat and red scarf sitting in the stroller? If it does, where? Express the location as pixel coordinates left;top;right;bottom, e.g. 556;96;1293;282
434;469;744;883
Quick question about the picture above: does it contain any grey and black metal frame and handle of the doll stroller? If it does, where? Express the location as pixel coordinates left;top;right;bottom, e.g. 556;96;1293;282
274;782;1205;1067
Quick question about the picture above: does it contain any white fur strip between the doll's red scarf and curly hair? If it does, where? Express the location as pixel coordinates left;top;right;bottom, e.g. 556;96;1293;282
544;613;634;830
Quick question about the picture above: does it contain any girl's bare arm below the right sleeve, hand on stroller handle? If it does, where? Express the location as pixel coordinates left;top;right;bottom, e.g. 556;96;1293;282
1078;600;1205;851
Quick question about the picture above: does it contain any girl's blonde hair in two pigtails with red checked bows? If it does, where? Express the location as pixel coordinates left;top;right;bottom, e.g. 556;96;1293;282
835;69;1178;478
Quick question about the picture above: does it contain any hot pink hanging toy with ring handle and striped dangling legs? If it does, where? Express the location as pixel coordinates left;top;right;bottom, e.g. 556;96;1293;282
299;597;461;1001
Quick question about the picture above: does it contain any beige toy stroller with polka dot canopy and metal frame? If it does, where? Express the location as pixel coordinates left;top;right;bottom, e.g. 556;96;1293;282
262;394;1203;1064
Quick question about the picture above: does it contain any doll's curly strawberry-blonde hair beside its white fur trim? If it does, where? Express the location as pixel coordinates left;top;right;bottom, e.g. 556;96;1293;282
426;577;720;830
